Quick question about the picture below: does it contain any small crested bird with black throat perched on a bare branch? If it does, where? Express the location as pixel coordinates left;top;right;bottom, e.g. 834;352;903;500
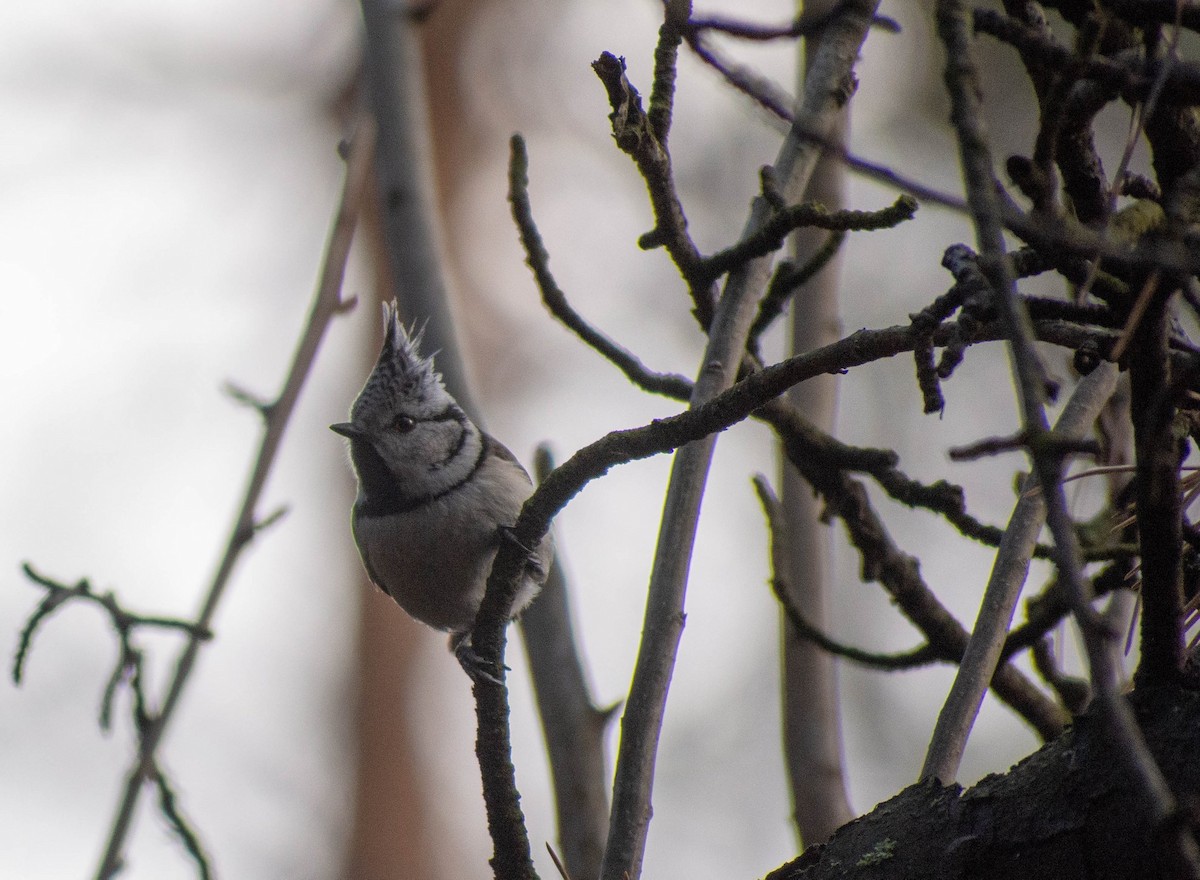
330;300;553;681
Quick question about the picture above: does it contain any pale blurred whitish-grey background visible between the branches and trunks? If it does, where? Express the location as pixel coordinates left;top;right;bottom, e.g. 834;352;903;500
0;0;1123;880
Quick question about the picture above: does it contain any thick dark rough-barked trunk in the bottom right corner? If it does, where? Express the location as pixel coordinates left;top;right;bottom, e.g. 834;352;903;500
767;688;1200;880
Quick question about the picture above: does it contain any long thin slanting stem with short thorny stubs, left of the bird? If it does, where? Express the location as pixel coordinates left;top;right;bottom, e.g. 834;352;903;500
96;120;374;880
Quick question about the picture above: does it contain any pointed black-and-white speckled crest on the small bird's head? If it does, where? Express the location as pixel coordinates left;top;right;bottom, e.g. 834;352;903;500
350;301;452;425
